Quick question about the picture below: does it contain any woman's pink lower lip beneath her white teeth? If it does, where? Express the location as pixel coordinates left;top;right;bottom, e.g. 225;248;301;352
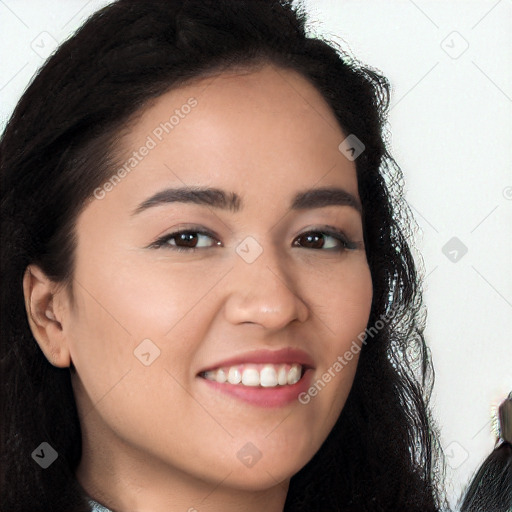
198;369;313;408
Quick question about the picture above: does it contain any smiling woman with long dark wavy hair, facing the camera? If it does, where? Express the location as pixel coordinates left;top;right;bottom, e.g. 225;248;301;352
1;0;443;512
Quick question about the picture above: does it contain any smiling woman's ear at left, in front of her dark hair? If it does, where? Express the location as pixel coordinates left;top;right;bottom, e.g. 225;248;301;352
23;265;71;368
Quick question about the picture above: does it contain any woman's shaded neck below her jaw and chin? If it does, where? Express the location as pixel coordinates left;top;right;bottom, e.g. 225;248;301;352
76;432;289;512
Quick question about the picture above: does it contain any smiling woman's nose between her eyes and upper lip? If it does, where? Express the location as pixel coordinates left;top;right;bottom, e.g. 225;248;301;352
225;241;310;331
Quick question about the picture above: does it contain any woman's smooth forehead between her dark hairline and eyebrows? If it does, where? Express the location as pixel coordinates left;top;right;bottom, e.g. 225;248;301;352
90;65;357;216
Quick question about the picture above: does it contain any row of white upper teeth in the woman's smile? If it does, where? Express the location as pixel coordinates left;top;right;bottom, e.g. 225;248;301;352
204;364;302;388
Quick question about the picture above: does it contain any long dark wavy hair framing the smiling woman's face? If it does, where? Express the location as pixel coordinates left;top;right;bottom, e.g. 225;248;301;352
0;0;444;512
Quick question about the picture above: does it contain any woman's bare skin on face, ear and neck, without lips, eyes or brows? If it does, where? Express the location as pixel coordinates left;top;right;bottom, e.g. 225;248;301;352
24;65;372;512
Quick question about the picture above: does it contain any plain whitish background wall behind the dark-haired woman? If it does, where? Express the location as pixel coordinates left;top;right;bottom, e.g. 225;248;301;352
0;0;512;510
